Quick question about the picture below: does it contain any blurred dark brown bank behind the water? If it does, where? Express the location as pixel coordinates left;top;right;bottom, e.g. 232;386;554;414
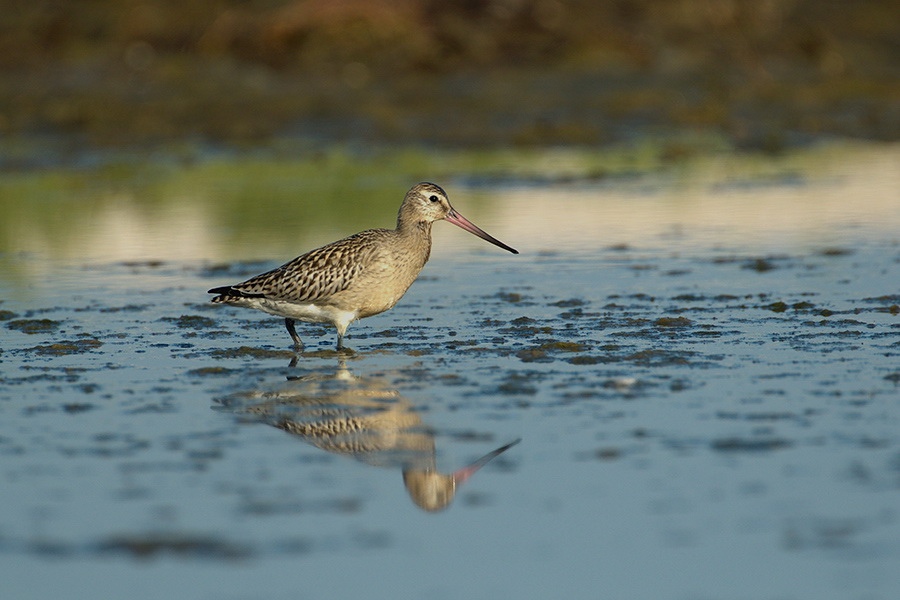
0;0;900;155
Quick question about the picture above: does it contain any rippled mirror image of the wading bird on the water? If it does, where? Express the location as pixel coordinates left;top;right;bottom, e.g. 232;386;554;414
219;369;520;511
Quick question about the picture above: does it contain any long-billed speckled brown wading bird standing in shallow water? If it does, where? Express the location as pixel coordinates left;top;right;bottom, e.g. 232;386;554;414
209;183;518;349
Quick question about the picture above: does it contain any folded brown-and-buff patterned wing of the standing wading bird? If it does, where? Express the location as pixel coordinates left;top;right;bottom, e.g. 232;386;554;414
223;229;388;302
